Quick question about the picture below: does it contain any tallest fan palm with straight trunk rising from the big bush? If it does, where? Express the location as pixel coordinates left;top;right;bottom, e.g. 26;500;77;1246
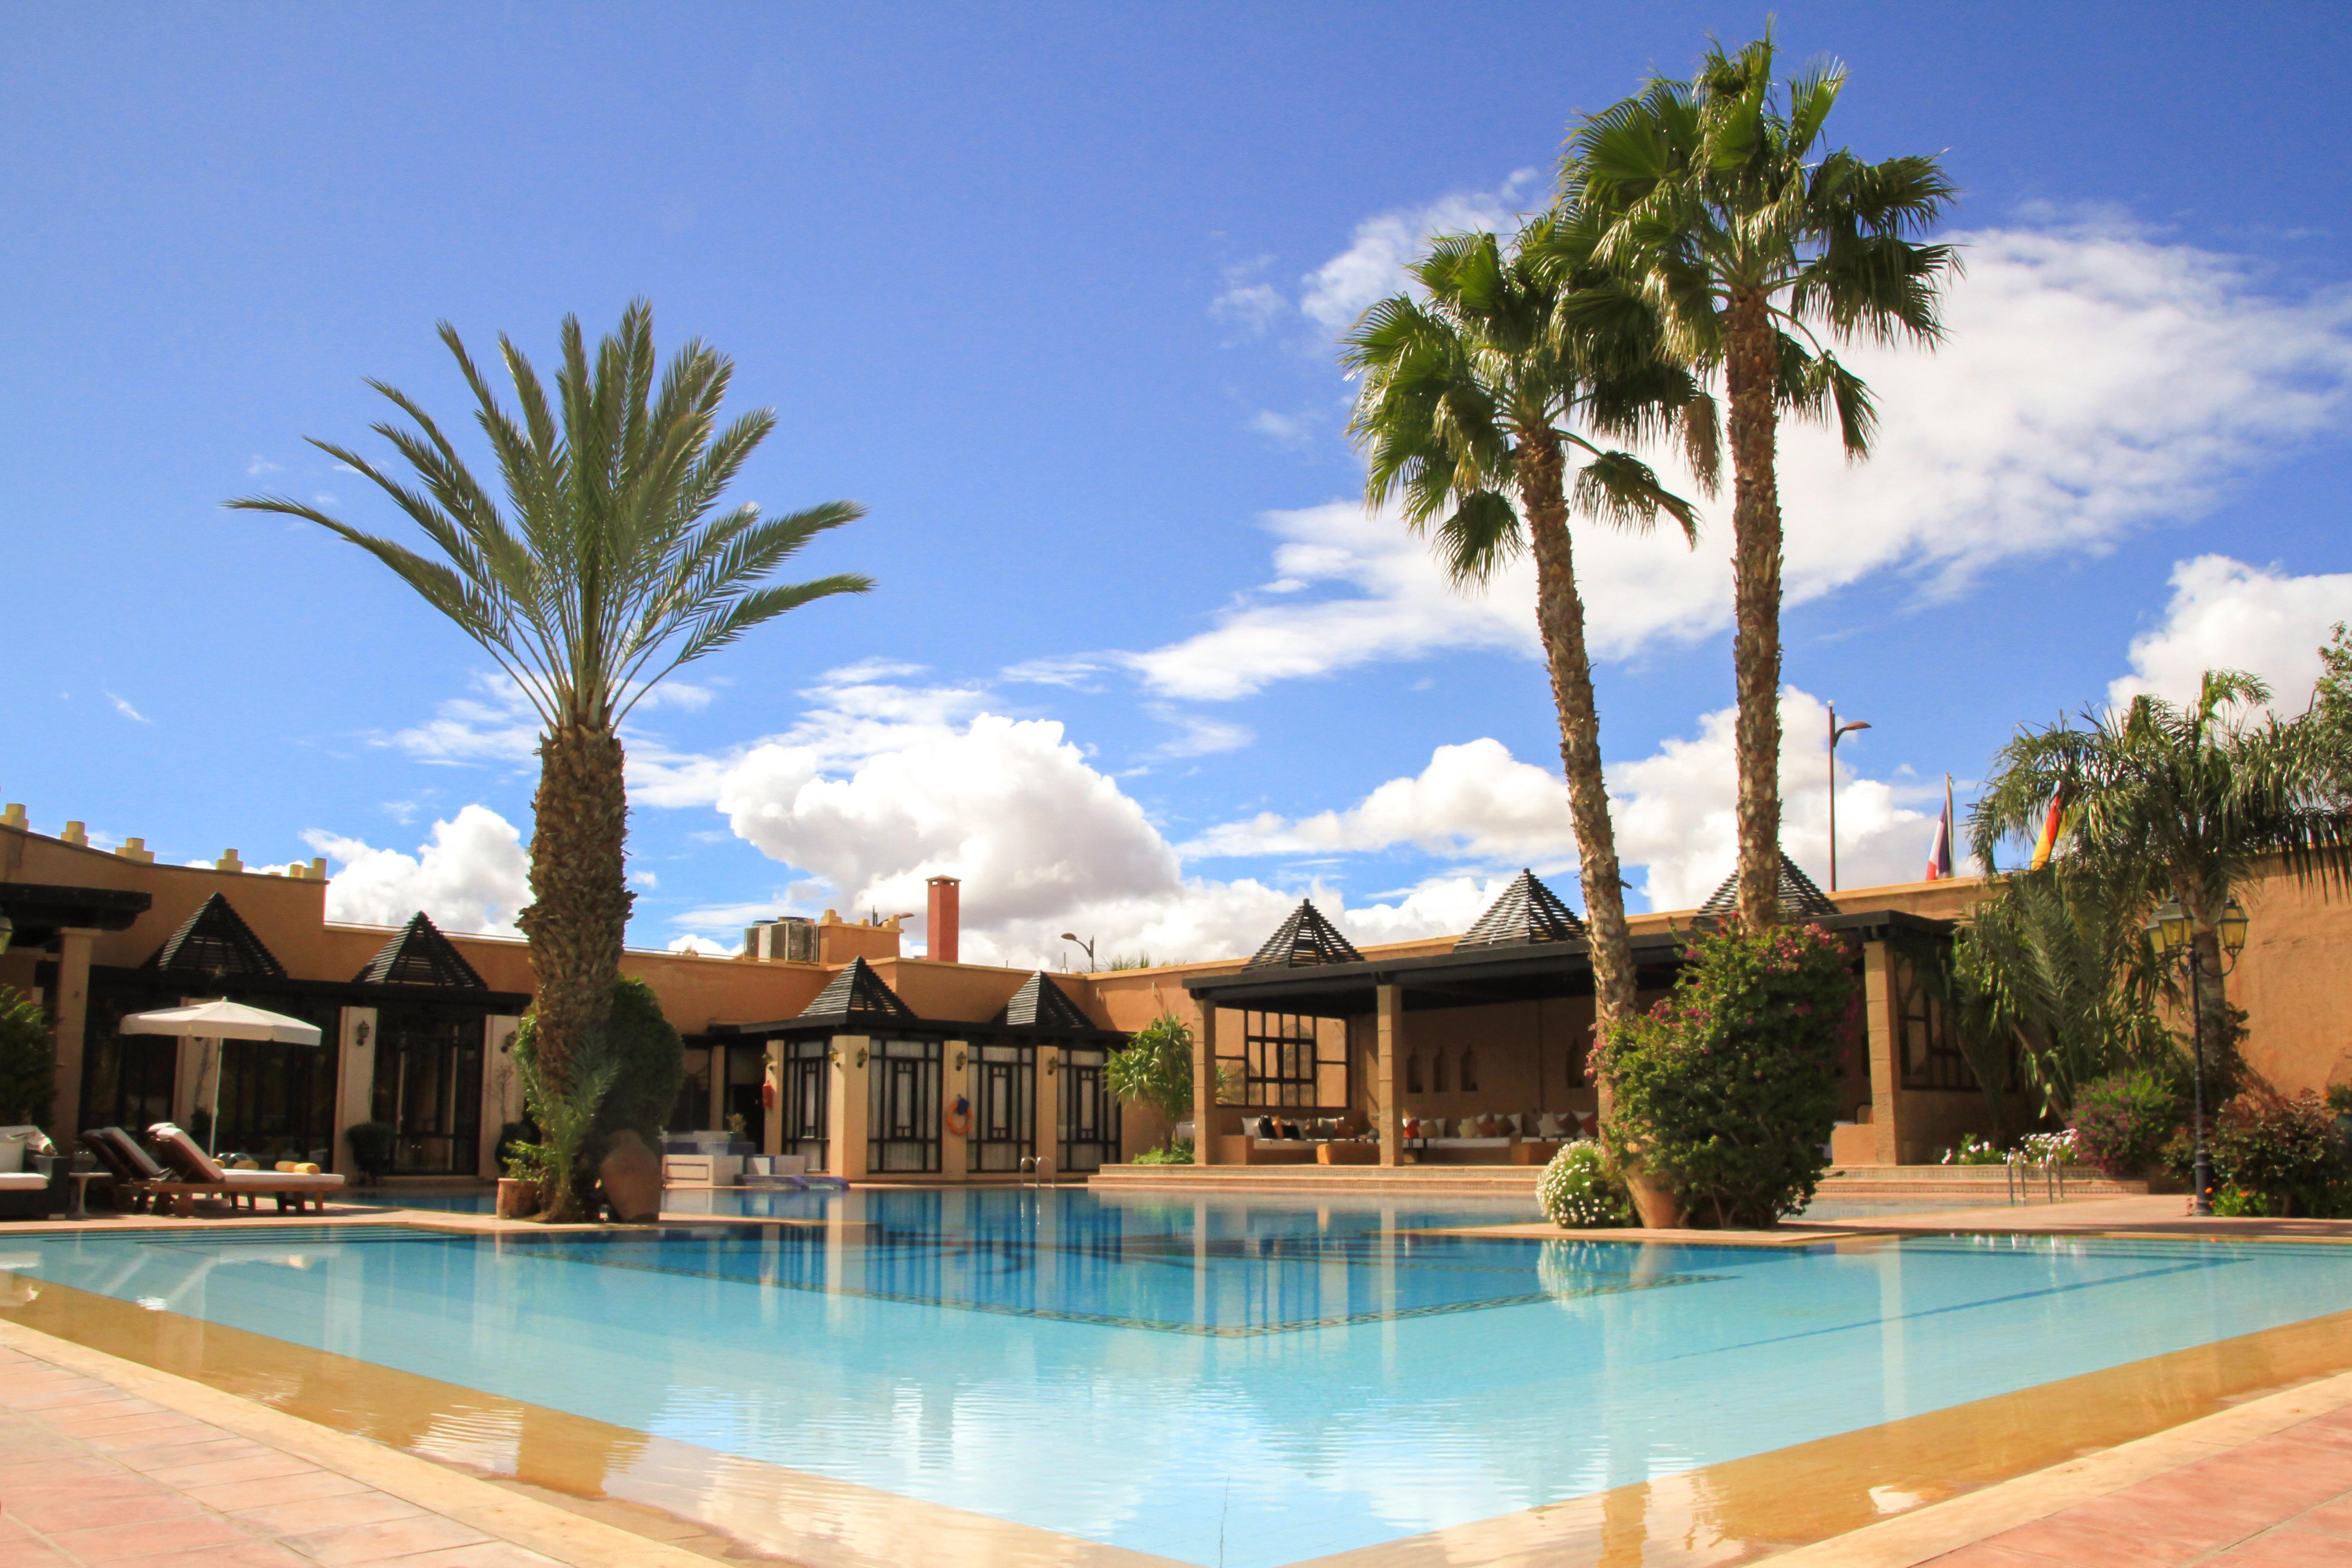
1559;33;1955;924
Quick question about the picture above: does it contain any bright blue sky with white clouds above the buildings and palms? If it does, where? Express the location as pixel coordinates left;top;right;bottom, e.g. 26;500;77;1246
0;5;2352;961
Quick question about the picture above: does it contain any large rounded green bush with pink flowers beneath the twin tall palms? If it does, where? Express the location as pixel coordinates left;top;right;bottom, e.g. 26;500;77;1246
1592;924;1853;1225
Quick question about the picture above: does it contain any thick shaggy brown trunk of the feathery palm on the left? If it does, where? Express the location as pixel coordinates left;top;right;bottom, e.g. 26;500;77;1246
515;724;635;1218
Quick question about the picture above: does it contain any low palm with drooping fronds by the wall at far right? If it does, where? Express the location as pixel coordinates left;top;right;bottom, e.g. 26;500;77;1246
1969;670;2352;1086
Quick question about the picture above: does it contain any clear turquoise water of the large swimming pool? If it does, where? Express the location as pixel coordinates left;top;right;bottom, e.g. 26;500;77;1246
10;1190;2352;1568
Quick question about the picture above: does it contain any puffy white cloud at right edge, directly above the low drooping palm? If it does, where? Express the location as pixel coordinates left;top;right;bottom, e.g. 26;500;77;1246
2107;555;2352;712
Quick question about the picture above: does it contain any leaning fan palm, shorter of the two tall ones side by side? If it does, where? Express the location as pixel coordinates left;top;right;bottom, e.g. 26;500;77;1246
1343;216;1715;1053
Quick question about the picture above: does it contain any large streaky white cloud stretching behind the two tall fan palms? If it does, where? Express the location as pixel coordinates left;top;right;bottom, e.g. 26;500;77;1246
1127;214;2352;701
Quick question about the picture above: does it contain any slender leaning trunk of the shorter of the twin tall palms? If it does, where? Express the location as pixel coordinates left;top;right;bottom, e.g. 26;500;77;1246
1517;437;1637;1112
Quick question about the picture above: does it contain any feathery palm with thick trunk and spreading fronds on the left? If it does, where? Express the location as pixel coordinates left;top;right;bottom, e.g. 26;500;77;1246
228;301;872;1204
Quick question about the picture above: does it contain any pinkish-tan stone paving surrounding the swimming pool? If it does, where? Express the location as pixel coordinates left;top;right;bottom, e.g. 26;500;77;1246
0;1196;2352;1568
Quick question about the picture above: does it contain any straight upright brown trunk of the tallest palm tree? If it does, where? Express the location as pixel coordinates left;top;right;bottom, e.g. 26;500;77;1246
1724;294;1780;929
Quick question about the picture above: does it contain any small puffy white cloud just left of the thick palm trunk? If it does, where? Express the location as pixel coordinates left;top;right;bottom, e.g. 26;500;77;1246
304;806;532;936
